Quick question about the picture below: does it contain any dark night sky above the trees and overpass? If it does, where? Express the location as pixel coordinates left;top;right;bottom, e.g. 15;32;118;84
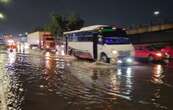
0;0;173;33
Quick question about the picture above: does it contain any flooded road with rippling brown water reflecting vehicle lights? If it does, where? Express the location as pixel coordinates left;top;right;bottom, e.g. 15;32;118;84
0;51;173;110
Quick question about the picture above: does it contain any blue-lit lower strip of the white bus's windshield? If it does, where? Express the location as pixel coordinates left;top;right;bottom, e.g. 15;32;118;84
103;37;131;45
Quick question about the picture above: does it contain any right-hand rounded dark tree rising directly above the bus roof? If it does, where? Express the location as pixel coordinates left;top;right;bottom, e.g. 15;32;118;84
66;14;84;31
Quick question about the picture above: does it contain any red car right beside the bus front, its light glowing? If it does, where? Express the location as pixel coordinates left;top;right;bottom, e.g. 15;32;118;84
135;46;167;61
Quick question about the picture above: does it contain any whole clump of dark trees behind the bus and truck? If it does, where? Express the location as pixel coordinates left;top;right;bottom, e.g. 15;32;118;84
44;14;84;38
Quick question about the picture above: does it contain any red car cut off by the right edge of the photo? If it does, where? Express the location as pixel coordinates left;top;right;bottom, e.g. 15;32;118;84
161;45;173;59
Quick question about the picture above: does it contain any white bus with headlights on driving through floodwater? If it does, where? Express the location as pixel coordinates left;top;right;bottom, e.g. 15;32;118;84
64;25;134;64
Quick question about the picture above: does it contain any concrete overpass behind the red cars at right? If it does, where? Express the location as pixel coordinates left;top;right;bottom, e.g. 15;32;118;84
127;24;173;44
